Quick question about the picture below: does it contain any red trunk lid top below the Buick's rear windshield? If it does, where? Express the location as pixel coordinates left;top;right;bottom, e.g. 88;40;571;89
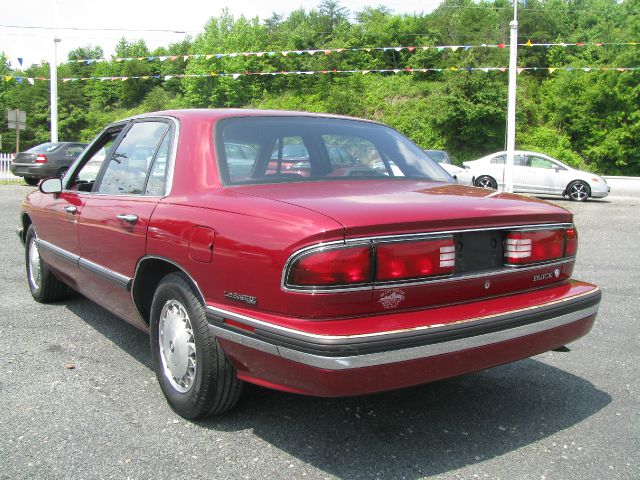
232;180;571;235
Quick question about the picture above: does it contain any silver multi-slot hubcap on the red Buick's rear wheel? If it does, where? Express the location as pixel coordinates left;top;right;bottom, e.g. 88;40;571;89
158;299;196;393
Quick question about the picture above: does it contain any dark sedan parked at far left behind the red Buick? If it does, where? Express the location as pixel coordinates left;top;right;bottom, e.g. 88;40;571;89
9;142;87;185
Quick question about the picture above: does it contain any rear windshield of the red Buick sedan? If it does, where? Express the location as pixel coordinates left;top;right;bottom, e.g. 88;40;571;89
216;116;452;185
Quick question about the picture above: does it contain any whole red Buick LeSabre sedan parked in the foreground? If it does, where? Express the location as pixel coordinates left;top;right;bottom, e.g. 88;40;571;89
18;110;600;418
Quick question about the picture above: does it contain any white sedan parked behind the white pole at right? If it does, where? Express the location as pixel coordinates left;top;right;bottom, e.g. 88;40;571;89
464;150;611;202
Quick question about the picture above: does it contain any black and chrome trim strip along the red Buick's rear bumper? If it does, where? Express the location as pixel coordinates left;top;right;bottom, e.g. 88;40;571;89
207;288;601;370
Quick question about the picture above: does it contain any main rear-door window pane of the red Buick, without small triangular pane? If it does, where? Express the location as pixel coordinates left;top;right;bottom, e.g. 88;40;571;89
97;122;169;195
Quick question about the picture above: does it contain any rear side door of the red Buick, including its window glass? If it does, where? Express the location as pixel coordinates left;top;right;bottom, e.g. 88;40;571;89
78;119;173;327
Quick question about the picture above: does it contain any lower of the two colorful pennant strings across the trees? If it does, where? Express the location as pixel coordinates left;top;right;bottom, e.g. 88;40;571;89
3;67;640;85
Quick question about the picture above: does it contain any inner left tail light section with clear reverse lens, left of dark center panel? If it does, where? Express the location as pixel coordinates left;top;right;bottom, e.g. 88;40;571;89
376;238;456;281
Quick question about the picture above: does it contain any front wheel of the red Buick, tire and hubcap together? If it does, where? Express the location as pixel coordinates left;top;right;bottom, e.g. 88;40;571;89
24;225;68;303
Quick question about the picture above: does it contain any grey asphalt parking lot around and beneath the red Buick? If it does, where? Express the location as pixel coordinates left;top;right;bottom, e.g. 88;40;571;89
0;179;640;480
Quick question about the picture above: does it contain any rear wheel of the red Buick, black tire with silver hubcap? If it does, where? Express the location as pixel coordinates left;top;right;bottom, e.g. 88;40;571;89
150;273;243;419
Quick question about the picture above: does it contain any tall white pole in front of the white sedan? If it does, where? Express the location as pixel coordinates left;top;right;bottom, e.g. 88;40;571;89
502;0;518;193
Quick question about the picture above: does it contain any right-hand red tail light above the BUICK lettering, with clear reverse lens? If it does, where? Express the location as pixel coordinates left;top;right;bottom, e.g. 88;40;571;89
504;227;578;265
